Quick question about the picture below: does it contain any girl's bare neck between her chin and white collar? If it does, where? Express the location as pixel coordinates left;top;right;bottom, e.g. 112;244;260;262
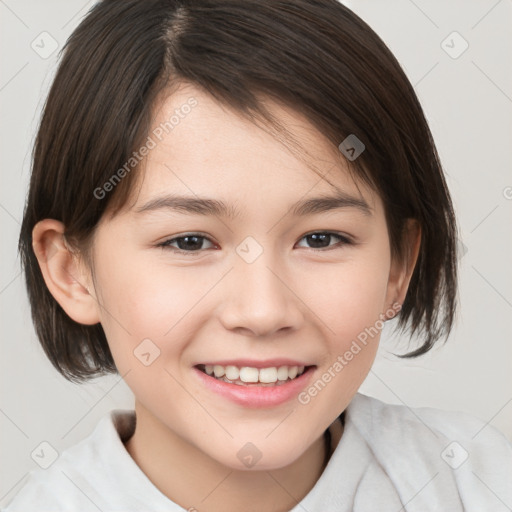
125;403;343;512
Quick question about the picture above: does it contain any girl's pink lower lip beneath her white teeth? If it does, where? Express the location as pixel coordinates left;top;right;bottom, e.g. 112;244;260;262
192;366;316;408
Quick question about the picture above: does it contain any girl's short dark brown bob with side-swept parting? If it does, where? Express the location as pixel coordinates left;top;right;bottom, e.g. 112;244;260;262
19;0;457;383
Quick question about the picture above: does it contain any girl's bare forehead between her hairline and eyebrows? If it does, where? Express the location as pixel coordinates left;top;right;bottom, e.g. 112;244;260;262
124;84;379;218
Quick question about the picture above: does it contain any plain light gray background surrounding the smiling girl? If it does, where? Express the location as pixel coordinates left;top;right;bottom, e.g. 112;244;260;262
0;0;512;503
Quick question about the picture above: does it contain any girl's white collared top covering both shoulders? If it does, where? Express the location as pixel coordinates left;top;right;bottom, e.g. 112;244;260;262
2;393;512;512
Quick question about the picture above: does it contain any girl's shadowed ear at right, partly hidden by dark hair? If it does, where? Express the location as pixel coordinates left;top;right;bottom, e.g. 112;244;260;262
386;219;421;318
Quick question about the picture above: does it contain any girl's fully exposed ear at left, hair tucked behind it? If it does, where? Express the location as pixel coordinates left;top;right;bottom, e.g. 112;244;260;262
32;219;100;325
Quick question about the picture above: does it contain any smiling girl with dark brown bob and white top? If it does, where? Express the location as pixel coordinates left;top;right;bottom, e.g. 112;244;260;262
5;0;512;512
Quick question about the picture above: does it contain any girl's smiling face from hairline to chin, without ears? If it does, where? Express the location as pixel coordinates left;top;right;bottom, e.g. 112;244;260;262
80;82;410;469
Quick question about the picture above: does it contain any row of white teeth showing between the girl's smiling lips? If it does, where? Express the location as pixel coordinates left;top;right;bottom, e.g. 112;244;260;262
195;364;316;387
